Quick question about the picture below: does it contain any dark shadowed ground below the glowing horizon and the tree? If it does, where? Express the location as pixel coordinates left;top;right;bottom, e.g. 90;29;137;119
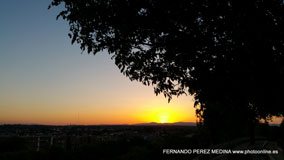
0;125;284;160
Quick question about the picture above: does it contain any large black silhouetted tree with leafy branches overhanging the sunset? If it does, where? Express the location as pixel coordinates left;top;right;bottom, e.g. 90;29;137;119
51;0;284;142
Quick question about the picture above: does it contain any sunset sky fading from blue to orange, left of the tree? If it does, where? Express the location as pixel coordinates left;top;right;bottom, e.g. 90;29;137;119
0;0;196;125
